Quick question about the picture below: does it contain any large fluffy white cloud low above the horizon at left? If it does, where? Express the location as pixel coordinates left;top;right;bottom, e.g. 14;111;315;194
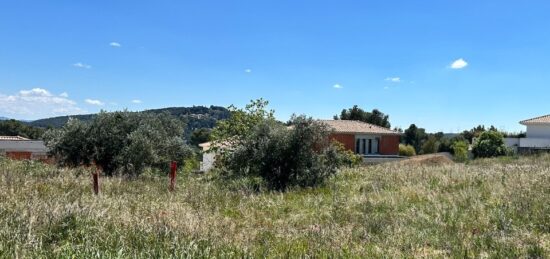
0;88;86;119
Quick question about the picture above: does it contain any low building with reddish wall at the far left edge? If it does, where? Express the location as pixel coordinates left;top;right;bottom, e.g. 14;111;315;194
0;136;48;160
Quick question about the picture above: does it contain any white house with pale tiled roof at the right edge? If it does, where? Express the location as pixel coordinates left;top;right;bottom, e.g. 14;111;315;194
505;115;550;153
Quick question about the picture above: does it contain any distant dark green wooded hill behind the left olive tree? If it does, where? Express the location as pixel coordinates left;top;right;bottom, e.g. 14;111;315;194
28;106;229;137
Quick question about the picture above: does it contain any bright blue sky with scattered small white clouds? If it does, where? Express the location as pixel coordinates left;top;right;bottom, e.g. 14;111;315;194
0;0;550;132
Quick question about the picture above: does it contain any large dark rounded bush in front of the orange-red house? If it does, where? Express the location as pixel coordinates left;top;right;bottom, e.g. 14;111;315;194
219;112;357;190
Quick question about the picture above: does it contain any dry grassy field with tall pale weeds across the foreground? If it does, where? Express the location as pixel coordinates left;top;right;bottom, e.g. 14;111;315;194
0;155;550;258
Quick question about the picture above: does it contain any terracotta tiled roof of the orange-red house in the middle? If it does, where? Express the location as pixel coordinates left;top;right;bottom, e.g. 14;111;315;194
320;120;401;135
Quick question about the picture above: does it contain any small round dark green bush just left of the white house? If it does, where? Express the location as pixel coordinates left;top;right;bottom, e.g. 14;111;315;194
472;130;507;158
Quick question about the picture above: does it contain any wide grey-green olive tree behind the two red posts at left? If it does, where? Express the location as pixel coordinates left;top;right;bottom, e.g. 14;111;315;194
44;111;192;175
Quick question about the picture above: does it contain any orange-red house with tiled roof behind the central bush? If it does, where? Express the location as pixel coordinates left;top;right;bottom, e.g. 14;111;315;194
321;120;401;160
